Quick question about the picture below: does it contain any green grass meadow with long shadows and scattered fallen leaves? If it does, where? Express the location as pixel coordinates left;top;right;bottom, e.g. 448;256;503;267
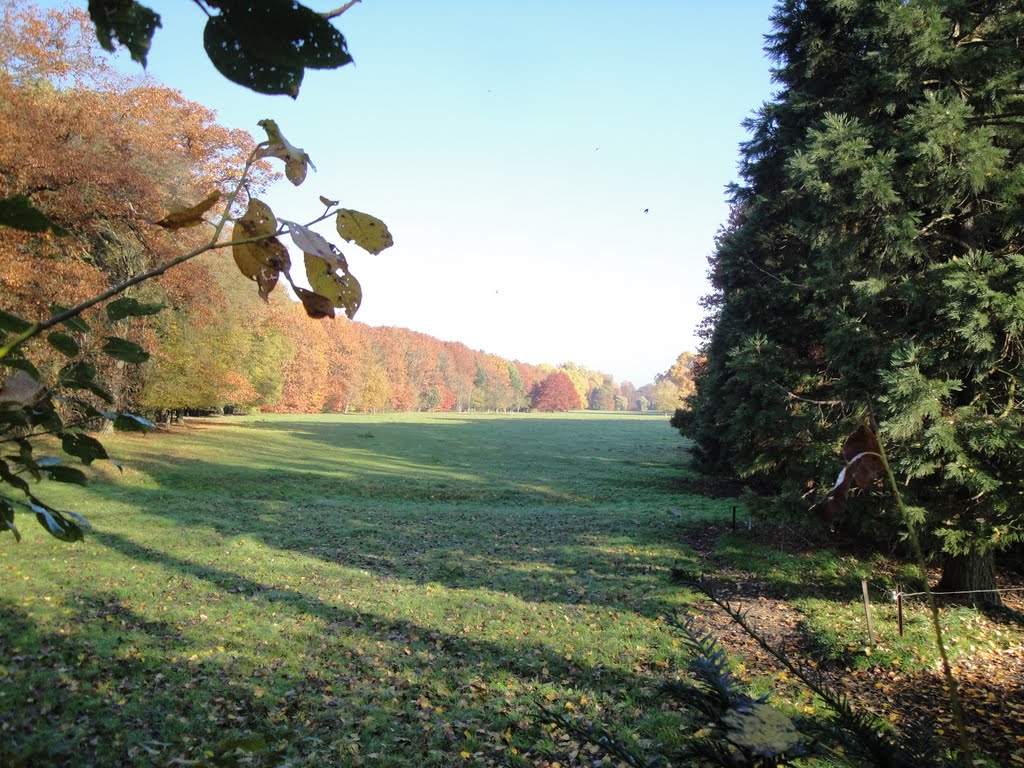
0;414;730;766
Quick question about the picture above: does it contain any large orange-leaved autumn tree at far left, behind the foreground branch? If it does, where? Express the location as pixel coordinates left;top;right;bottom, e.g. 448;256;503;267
0;3;269;423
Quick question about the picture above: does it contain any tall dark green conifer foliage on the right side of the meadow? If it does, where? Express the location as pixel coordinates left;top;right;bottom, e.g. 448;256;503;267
677;0;1024;587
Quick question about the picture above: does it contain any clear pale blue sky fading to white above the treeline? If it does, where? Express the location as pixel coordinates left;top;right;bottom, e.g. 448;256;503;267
45;0;772;385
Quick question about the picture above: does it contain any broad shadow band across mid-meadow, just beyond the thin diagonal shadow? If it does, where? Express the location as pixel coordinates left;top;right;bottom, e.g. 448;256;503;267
86;470;704;616
